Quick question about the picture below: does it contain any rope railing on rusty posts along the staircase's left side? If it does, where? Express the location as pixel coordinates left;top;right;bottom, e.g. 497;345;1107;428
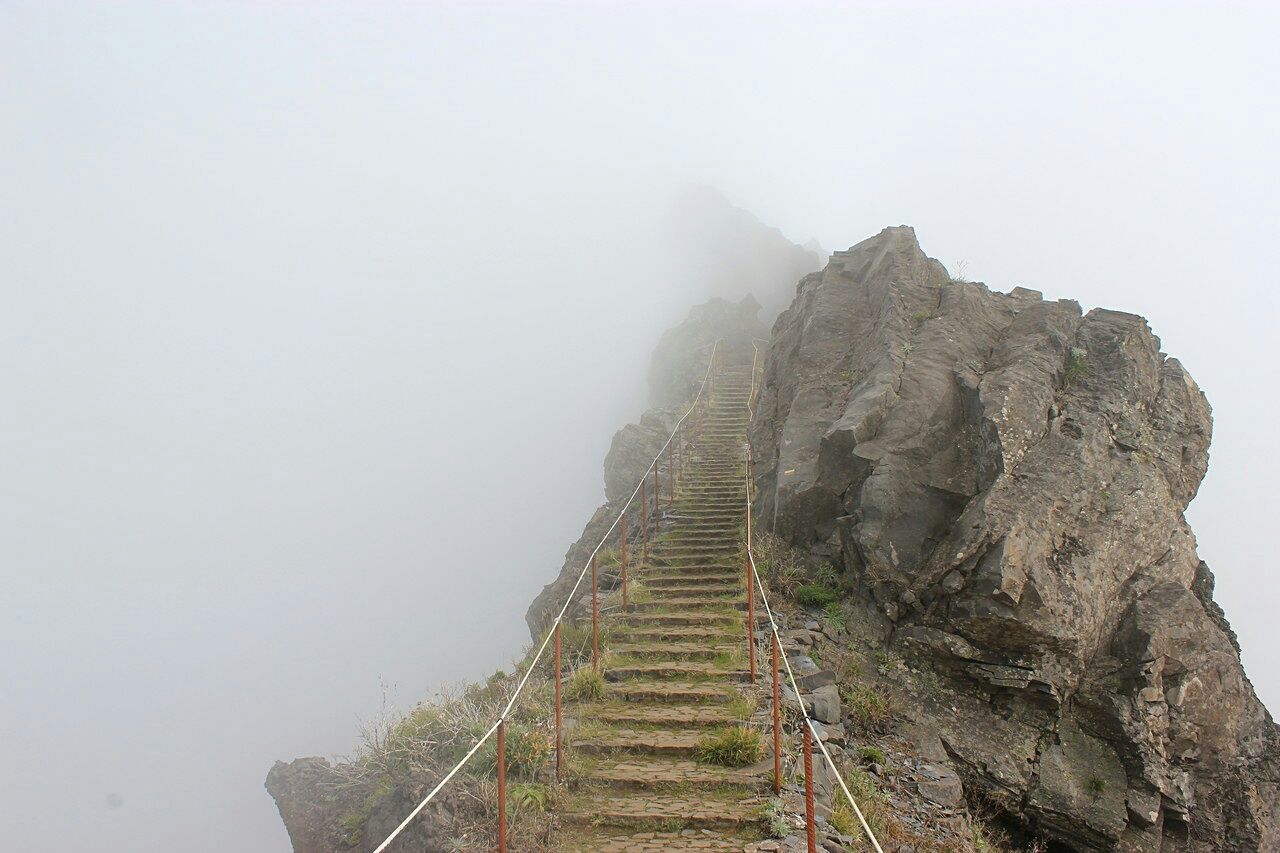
374;341;721;853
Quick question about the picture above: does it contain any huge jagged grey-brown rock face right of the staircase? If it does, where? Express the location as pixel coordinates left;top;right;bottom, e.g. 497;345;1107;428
751;227;1280;850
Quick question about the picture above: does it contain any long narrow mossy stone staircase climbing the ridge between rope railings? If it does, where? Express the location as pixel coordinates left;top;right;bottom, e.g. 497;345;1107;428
559;359;772;853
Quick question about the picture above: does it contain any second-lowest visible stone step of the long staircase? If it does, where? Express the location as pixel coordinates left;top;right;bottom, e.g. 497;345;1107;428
563;790;764;824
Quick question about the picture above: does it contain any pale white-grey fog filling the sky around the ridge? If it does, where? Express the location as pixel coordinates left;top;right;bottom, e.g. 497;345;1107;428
0;0;1280;853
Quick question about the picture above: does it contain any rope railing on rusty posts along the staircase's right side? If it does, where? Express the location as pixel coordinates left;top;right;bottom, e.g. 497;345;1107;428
744;341;884;853
